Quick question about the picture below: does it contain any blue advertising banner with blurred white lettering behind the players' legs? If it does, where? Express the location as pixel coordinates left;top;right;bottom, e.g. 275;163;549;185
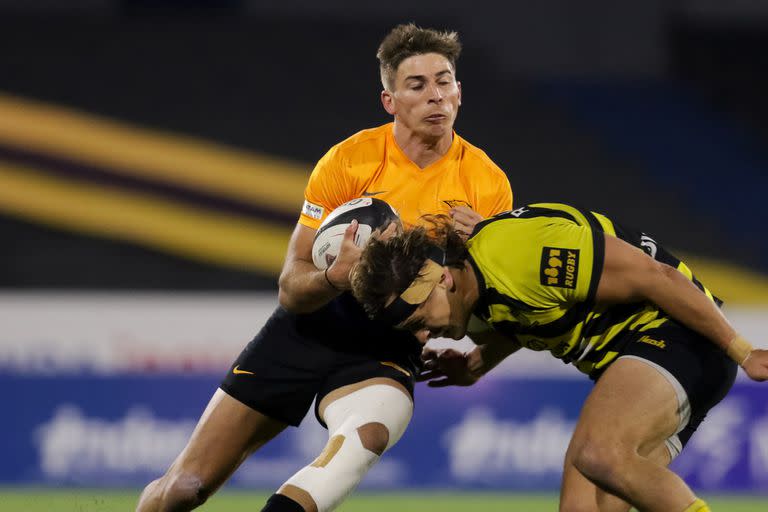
0;373;768;492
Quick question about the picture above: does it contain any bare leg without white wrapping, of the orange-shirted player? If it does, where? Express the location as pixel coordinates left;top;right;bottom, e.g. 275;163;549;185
136;389;287;512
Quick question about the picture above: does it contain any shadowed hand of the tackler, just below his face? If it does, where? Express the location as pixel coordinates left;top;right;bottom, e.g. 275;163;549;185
416;347;483;388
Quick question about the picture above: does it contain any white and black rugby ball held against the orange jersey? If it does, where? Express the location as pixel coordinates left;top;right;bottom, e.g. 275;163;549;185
312;197;400;270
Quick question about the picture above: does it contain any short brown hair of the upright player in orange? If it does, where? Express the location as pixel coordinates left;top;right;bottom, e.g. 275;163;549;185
376;23;461;90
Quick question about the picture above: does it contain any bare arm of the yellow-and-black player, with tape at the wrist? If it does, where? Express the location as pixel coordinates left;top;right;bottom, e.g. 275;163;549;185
595;236;768;380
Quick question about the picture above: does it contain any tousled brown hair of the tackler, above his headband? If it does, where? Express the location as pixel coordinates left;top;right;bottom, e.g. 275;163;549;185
350;215;469;318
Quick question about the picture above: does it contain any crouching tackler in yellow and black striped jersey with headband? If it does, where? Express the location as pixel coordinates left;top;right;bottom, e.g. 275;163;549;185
352;203;768;512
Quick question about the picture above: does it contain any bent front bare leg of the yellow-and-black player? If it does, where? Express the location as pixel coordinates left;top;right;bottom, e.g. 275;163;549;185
569;359;696;512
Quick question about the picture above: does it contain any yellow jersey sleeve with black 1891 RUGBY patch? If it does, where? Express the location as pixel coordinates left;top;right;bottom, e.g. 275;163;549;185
481;218;605;308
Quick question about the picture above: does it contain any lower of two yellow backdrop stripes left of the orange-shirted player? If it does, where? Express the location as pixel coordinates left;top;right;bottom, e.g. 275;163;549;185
0;164;291;274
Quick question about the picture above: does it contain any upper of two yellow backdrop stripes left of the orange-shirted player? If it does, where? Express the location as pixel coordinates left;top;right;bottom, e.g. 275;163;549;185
0;94;312;212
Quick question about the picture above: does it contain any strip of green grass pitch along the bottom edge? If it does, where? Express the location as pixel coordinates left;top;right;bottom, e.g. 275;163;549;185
0;488;768;512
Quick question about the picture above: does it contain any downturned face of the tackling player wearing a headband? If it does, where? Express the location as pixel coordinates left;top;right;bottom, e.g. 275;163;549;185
398;270;470;343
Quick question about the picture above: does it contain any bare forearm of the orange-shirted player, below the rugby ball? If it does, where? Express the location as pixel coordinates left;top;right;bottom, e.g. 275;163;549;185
278;260;341;313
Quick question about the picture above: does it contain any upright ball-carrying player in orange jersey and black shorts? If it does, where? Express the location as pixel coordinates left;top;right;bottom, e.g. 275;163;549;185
138;24;512;512
